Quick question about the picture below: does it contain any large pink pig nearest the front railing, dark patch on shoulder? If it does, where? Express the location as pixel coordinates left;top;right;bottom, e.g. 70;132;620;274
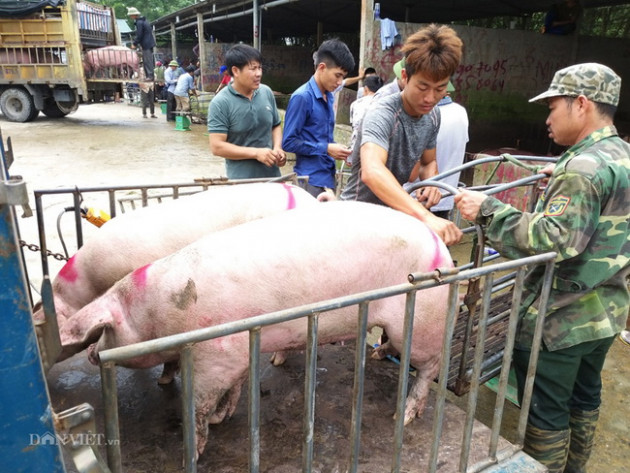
61;201;453;454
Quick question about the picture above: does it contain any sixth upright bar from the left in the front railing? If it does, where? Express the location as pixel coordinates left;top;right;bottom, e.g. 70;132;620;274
392;291;417;473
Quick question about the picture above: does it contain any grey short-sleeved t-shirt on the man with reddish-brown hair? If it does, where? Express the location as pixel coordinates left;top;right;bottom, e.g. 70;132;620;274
340;93;440;205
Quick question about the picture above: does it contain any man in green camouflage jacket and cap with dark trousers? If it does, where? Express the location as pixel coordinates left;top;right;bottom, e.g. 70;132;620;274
455;63;630;473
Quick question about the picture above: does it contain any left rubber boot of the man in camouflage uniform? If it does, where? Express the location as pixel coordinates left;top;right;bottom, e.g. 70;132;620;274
523;424;571;473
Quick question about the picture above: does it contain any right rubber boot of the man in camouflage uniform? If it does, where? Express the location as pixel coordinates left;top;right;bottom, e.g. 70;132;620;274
564;409;599;473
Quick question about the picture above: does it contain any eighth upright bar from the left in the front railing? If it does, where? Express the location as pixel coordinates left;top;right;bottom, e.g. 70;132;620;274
459;273;493;473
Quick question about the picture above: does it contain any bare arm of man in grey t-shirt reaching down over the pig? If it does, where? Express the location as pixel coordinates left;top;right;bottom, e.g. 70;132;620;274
361;143;462;245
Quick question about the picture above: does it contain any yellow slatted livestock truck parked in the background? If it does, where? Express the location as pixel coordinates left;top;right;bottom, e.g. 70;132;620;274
0;0;130;122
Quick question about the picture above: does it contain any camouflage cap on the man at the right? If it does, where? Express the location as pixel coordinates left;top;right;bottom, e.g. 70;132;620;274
530;62;621;106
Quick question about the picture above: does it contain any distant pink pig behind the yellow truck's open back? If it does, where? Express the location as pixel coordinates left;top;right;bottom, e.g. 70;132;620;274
83;46;139;79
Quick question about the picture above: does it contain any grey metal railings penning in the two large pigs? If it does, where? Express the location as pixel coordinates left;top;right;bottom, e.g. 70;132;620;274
17;157;555;472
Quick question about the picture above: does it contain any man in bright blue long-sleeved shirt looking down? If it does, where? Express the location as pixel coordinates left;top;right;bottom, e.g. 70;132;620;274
282;39;354;196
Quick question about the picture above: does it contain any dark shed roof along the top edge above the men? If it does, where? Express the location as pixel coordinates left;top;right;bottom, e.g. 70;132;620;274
153;0;630;41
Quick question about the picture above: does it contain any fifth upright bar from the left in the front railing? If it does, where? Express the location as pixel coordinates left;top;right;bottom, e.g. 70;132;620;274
348;302;368;473
